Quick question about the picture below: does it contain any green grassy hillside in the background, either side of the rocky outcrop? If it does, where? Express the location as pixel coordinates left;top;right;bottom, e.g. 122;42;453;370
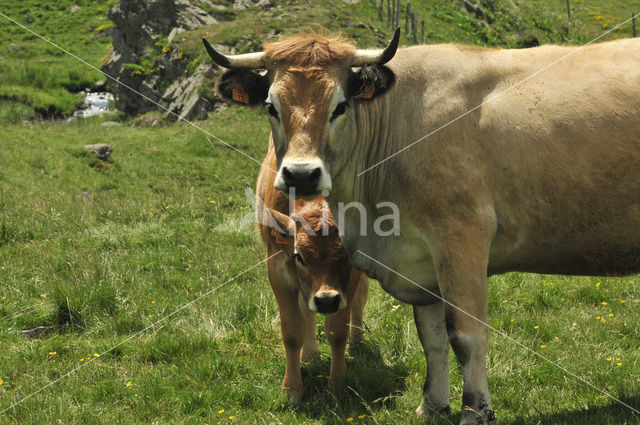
0;0;640;122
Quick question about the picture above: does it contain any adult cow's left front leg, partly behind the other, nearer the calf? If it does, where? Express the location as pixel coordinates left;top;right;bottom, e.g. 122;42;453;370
413;301;450;416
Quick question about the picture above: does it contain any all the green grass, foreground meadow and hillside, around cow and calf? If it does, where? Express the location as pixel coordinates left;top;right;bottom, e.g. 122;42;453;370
0;0;640;425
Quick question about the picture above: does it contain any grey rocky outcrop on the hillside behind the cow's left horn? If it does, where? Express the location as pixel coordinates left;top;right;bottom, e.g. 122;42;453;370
102;0;224;120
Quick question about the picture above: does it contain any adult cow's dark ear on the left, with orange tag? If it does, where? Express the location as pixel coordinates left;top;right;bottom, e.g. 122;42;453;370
216;69;269;106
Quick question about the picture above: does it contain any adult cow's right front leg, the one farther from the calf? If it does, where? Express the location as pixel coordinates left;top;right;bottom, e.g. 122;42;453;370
434;222;495;425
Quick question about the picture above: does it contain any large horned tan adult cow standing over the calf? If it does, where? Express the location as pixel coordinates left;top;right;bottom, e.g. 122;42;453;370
204;28;640;424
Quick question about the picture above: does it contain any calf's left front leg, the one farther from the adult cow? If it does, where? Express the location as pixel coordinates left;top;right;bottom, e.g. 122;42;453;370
267;260;305;404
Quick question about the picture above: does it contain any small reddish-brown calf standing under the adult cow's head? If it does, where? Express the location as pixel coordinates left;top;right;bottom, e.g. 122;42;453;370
256;140;369;404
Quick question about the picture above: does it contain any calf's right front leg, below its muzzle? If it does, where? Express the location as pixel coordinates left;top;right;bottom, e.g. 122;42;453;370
324;305;351;391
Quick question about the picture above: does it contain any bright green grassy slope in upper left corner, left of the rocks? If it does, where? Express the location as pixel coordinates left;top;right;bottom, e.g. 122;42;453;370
0;0;116;122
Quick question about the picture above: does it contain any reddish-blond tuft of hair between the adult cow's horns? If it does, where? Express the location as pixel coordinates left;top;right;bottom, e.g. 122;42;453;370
263;29;356;67
